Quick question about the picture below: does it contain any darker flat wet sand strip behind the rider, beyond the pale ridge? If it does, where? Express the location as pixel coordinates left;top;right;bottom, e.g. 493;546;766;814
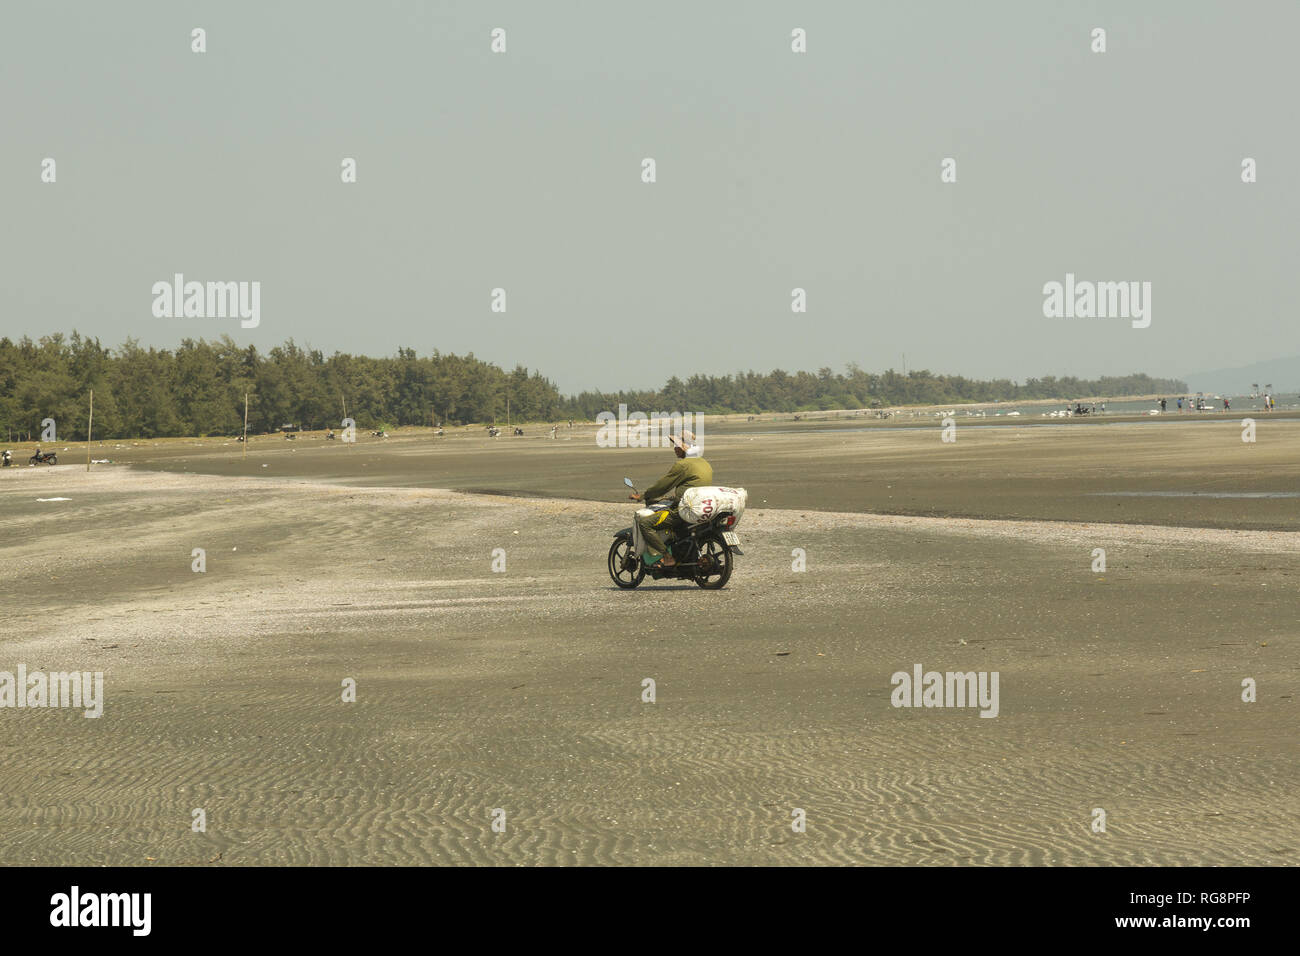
63;418;1300;531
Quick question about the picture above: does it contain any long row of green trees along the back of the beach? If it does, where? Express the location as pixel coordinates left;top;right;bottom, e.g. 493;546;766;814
0;332;1187;440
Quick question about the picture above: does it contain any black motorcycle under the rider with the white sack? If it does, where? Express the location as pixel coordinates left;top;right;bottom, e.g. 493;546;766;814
610;477;744;591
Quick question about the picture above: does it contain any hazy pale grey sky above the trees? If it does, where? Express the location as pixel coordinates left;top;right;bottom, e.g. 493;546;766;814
0;0;1300;392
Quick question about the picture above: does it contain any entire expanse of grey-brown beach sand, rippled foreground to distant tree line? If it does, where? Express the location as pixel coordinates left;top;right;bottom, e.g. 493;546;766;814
0;423;1300;865
